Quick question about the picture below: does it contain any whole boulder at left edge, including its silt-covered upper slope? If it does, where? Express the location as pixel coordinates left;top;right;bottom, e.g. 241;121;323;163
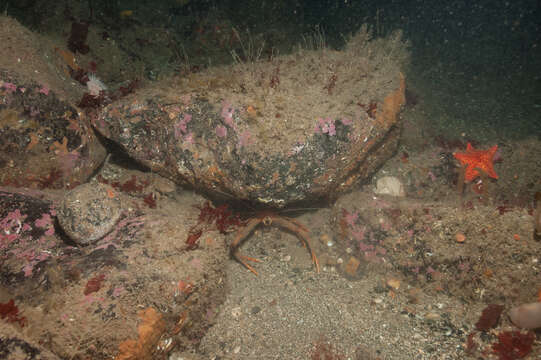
0;16;106;189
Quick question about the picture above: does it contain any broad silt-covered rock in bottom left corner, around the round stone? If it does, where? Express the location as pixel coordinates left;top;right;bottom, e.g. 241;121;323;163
0;184;229;359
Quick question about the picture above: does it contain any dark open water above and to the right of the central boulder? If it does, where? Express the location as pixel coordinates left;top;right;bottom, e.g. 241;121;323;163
4;0;541;142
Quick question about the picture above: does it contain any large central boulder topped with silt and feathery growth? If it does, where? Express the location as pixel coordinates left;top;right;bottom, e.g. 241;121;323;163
93;30;407;207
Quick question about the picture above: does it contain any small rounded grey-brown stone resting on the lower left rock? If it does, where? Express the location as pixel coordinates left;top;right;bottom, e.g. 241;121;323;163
58;184;122;245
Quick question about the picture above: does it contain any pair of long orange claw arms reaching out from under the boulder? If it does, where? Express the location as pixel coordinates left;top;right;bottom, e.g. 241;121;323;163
231;213;319;275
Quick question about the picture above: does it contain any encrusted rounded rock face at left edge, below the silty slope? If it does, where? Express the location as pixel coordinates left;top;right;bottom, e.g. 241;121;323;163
0;69;105;189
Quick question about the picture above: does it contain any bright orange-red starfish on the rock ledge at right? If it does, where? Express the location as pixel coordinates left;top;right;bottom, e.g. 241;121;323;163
453;143;498;182
